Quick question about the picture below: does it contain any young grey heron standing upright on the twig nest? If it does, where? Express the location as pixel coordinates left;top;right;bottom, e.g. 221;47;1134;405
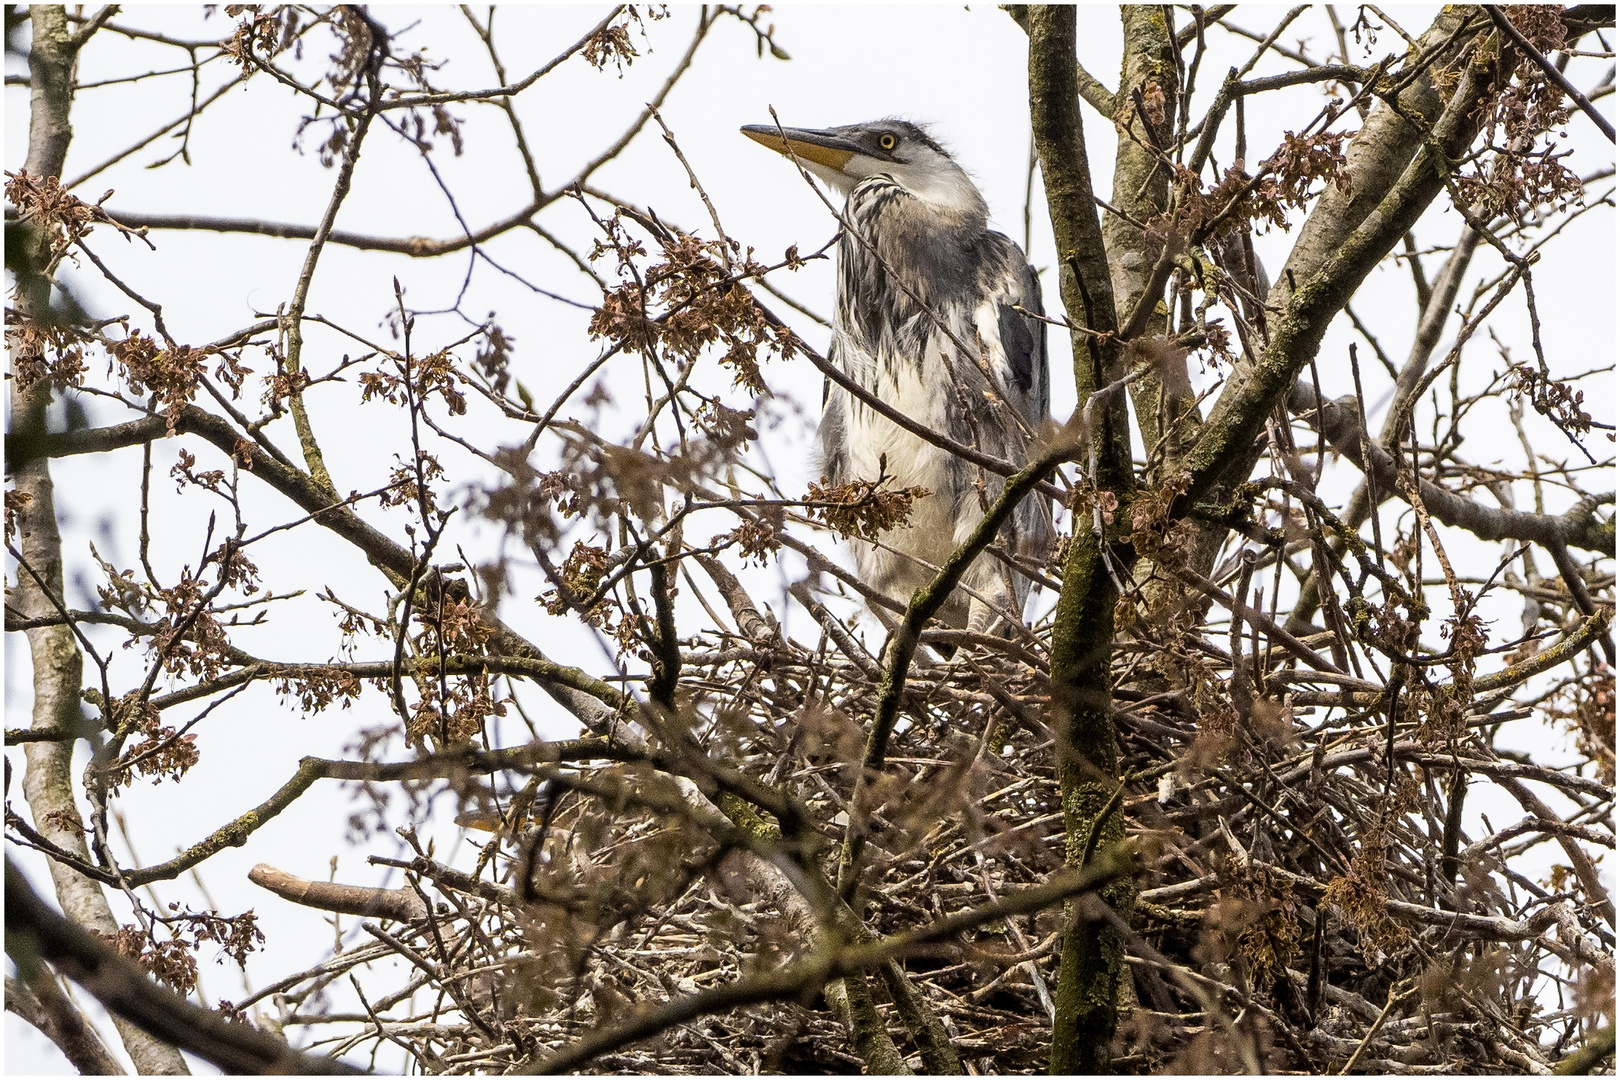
742;120;1053;633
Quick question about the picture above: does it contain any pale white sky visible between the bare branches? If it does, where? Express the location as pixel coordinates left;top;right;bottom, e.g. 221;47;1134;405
5;5;1615;1072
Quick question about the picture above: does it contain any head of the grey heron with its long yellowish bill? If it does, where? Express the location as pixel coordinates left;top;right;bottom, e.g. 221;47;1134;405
742;120;987;215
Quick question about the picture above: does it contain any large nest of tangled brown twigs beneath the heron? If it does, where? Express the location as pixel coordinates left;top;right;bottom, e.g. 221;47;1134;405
259;582;1614;1074
